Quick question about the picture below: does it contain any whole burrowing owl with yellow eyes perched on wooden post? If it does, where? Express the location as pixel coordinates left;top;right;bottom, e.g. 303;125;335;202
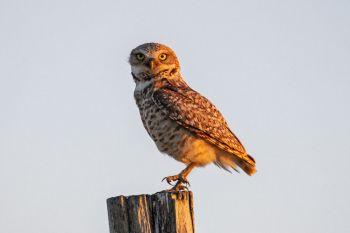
129;43;256;190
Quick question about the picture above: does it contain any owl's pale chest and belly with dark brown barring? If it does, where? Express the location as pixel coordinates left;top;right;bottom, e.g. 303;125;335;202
134;83;187;158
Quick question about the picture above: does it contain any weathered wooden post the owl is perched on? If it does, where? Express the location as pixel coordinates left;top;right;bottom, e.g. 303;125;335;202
107;191;194;233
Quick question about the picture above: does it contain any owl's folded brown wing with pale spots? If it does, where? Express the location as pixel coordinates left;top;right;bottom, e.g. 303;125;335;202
153;82;254;163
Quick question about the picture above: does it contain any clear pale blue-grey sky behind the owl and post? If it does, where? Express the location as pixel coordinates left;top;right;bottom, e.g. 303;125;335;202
0;0;350;233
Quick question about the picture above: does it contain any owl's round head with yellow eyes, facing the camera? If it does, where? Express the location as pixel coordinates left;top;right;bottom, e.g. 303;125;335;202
129;43;180;80
